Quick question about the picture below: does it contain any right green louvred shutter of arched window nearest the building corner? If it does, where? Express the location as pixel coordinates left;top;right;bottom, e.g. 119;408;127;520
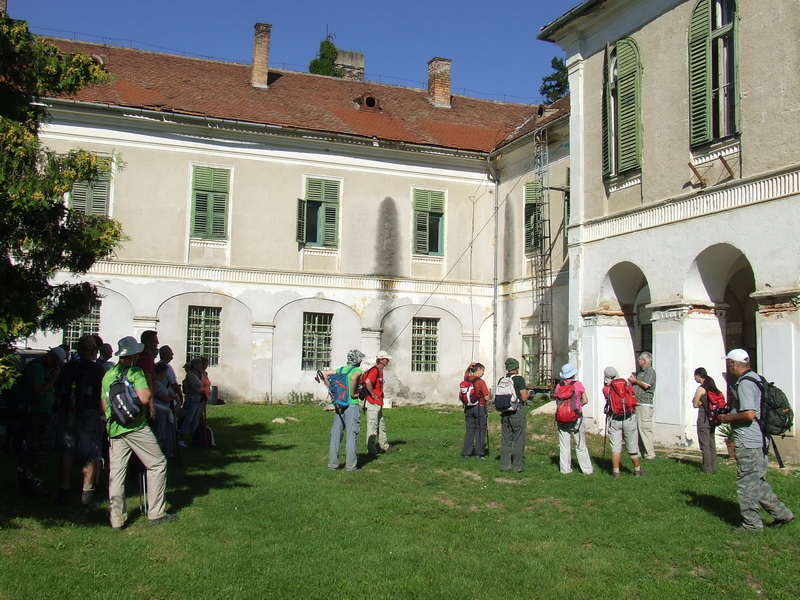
616;39;641;173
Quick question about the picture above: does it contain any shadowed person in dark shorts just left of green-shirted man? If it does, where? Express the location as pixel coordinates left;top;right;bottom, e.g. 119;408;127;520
56;335;105;506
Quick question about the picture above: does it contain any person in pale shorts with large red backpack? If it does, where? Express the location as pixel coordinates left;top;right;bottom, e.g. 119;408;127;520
603;367;644;477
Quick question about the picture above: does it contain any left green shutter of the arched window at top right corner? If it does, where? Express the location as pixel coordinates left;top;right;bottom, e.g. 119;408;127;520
689;0;711;147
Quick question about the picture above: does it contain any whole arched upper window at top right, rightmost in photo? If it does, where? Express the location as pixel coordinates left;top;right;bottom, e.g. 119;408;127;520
689;0;739;147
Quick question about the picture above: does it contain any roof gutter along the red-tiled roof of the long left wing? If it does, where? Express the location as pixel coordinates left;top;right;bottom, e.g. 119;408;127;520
47;98;487;160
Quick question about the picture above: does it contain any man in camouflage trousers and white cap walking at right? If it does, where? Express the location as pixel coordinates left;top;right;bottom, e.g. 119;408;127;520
719;348;794;533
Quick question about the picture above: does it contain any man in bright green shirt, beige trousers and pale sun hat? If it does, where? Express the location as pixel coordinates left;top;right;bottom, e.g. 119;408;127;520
102;336;177;529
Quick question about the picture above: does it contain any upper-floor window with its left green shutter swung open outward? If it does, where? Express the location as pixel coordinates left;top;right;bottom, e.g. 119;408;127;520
297;178;339;248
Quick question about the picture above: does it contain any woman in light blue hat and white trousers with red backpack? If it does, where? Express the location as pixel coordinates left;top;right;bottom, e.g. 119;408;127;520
554;363;594;475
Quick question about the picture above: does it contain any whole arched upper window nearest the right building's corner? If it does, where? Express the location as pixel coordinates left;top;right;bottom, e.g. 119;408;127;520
602;38;642;177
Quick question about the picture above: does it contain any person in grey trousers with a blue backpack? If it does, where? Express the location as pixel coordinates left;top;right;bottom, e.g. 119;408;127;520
317;349;364;471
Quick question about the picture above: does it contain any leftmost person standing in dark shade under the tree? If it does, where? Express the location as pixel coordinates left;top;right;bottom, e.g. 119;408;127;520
19;346;67;496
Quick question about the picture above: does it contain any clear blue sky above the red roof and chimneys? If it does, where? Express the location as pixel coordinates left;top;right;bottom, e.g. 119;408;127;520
8;0;580;103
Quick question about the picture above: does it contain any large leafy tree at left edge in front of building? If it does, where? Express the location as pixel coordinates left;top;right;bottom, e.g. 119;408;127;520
0;10;123;387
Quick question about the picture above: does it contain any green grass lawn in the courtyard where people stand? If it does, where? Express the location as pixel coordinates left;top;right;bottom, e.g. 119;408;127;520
0;405;800;600
